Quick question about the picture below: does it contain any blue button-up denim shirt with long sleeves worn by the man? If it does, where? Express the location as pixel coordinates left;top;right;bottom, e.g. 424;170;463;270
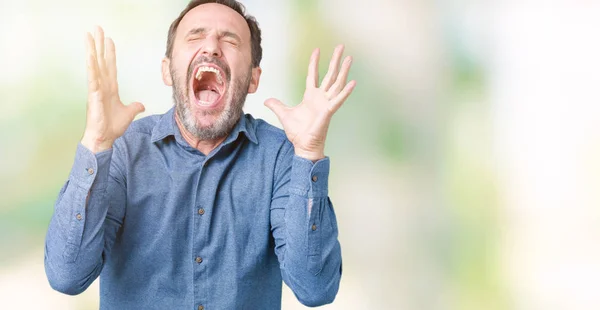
44;108;342;310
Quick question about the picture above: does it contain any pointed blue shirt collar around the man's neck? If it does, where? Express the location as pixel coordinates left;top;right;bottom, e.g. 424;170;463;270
151;107;258;144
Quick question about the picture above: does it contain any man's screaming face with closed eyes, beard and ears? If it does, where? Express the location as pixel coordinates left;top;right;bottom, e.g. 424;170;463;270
163;3;260;140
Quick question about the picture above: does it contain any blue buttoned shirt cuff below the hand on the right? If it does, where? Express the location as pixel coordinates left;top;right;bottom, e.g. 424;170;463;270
290;155;329;198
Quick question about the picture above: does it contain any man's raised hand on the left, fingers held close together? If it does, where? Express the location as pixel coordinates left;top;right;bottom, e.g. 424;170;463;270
81;27;145;153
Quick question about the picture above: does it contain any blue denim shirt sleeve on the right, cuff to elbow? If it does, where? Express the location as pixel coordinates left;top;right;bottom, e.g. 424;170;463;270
271;142;342;306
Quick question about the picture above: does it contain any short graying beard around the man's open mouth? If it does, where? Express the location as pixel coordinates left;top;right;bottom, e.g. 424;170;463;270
171;66;252;140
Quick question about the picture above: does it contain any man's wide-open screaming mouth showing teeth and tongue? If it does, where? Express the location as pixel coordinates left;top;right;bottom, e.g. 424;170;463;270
192;65;227;107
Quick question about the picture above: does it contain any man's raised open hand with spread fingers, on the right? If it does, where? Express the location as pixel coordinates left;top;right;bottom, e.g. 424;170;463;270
265;45;356;161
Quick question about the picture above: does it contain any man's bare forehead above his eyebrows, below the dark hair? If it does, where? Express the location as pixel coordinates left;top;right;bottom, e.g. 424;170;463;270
177;3;250;42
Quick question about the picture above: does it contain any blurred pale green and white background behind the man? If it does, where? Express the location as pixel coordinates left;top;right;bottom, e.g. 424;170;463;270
0;0;600;310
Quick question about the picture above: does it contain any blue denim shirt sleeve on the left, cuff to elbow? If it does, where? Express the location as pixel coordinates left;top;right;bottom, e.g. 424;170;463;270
44;144;125;295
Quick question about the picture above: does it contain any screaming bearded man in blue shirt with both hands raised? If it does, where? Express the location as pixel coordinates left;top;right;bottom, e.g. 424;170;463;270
45;0;355;310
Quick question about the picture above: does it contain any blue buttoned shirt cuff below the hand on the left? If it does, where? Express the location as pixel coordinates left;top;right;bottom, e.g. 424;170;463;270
70;143;113;189
